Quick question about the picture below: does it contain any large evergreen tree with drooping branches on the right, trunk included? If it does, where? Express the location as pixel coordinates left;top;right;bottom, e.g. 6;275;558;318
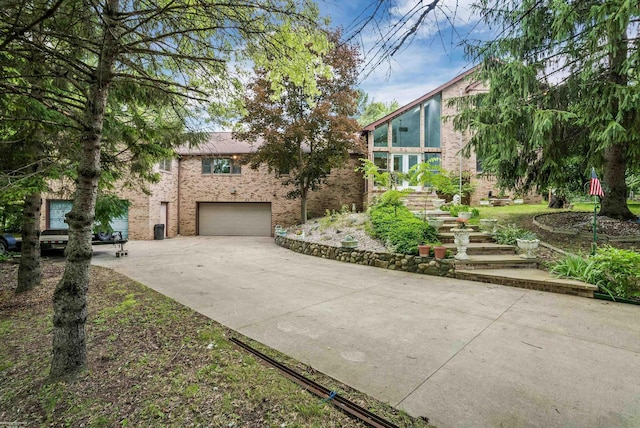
455;0;640;219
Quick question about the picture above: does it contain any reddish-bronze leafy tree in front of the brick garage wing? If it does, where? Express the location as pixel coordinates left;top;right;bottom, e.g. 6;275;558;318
234;33;360;223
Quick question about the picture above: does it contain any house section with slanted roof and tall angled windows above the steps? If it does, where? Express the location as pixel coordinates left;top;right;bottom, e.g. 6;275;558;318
363;69;498;205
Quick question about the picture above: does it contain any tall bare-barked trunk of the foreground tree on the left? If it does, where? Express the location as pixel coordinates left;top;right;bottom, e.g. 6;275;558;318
49;0;118;379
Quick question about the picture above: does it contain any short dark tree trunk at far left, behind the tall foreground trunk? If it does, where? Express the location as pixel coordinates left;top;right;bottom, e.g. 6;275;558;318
16;192;42;293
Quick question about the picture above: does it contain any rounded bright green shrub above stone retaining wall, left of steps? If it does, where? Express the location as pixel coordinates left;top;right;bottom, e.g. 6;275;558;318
370;204;438;254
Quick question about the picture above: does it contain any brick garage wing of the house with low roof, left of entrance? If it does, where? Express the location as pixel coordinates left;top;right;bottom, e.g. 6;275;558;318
41;132;364;239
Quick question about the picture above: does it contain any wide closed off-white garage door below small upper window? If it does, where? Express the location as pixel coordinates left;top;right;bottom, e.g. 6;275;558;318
198;202;271;236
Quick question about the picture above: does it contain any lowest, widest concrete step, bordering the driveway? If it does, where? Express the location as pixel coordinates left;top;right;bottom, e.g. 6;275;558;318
456;268;598;298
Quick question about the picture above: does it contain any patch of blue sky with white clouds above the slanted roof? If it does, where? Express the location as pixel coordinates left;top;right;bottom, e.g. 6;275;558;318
318;0;490;105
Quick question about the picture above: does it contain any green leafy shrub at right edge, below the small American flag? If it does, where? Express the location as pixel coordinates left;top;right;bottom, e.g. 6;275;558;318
550;246;640;298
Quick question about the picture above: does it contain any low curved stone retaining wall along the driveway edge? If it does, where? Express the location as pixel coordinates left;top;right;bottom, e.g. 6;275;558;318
275;236;455;278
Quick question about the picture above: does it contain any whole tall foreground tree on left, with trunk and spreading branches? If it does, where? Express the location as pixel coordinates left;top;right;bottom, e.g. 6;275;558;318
0;0;324;378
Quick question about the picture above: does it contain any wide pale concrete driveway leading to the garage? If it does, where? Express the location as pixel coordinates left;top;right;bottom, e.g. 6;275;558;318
93;237;640;427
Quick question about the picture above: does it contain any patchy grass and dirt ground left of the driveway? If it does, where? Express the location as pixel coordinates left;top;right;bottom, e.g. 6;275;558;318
0;261;429;428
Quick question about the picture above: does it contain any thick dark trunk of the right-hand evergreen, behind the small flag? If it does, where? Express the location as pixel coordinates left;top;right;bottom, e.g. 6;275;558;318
600;144;637;220
